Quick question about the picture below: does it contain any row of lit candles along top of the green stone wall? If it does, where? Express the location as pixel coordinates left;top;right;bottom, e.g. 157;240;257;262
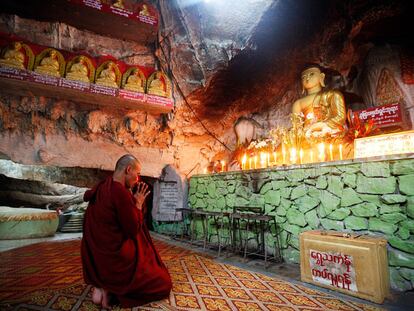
240;143;343;170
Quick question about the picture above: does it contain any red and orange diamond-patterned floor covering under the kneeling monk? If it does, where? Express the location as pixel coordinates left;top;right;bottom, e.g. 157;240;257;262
0;241;380;311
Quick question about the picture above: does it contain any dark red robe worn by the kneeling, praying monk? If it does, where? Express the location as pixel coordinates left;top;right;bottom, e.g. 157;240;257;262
81;177;172;307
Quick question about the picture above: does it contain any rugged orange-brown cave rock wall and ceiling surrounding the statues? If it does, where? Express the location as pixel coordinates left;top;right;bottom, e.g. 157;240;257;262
0;0;414;180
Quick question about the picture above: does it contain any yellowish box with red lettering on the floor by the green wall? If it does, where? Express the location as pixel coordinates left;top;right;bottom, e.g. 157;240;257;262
300;230;389;303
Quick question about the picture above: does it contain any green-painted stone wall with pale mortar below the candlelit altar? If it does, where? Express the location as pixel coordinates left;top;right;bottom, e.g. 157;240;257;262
184;158;414;291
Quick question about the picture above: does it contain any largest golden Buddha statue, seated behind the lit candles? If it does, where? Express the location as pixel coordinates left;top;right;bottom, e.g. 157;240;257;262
292;66;346;140
